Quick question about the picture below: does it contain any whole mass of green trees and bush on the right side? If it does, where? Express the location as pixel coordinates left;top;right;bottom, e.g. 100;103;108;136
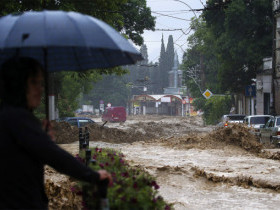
181;0;273;124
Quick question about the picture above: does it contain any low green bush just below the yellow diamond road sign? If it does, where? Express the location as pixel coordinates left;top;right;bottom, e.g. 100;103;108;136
199;96;232;125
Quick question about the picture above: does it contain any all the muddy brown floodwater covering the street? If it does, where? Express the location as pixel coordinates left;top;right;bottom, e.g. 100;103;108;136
49;117;280;209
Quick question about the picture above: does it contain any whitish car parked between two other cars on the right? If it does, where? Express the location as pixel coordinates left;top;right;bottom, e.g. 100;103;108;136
244;115;272;136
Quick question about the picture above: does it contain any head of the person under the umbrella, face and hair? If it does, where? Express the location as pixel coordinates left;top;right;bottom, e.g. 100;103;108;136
0;57;44;110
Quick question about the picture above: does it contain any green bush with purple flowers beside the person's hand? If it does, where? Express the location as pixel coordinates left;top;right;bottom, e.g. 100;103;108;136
75;148;171;210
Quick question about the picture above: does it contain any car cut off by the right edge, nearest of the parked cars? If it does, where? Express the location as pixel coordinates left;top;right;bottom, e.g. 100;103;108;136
260;116;280;146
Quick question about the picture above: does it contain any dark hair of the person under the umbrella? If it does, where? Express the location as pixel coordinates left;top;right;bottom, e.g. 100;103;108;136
0;57;43;108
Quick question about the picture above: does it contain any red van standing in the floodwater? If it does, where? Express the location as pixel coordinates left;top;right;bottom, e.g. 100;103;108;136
102;106;126;122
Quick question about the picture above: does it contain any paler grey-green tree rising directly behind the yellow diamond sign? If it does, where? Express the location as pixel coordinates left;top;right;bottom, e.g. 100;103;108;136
181;17;220;98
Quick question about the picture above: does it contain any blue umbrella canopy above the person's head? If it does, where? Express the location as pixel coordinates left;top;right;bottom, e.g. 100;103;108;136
0;10;142;72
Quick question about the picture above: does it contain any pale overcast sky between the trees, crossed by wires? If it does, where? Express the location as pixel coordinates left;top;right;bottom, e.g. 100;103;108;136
143;0;206;62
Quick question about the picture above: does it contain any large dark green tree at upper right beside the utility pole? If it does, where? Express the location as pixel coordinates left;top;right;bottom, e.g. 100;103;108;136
203;0;272;93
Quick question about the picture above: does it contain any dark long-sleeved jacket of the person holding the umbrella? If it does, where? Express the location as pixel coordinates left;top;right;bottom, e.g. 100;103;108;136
0;107;99;209
